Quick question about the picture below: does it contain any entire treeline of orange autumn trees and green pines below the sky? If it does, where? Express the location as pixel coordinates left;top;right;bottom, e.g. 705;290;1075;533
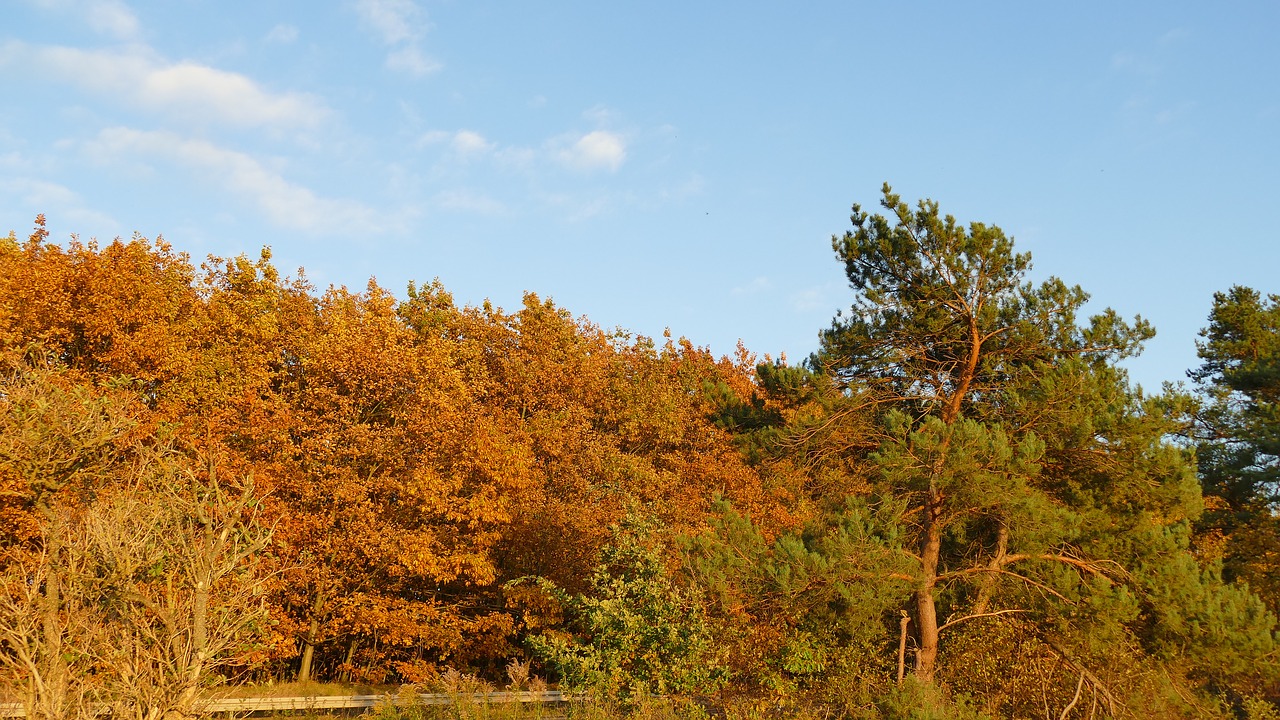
0;187;1280;719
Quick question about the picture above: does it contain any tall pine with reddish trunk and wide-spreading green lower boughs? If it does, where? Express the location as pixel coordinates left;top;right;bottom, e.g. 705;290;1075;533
699;186;1274;715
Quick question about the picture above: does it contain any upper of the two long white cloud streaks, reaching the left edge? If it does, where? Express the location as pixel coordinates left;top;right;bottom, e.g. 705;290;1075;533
0;42;329;128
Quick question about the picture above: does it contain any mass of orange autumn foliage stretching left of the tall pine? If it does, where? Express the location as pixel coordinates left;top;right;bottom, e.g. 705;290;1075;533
0;225;794;680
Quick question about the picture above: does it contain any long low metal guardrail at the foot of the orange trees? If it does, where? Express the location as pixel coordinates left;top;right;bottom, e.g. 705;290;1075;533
0;691;567;717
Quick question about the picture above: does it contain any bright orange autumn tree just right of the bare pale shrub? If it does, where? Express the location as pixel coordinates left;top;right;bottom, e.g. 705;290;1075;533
271;283;527;680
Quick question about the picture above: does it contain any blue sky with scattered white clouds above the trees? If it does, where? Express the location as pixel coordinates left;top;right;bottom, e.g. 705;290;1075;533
0;0;1280;388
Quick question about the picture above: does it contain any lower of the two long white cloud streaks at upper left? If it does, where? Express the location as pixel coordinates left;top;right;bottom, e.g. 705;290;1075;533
88;128;384;234
